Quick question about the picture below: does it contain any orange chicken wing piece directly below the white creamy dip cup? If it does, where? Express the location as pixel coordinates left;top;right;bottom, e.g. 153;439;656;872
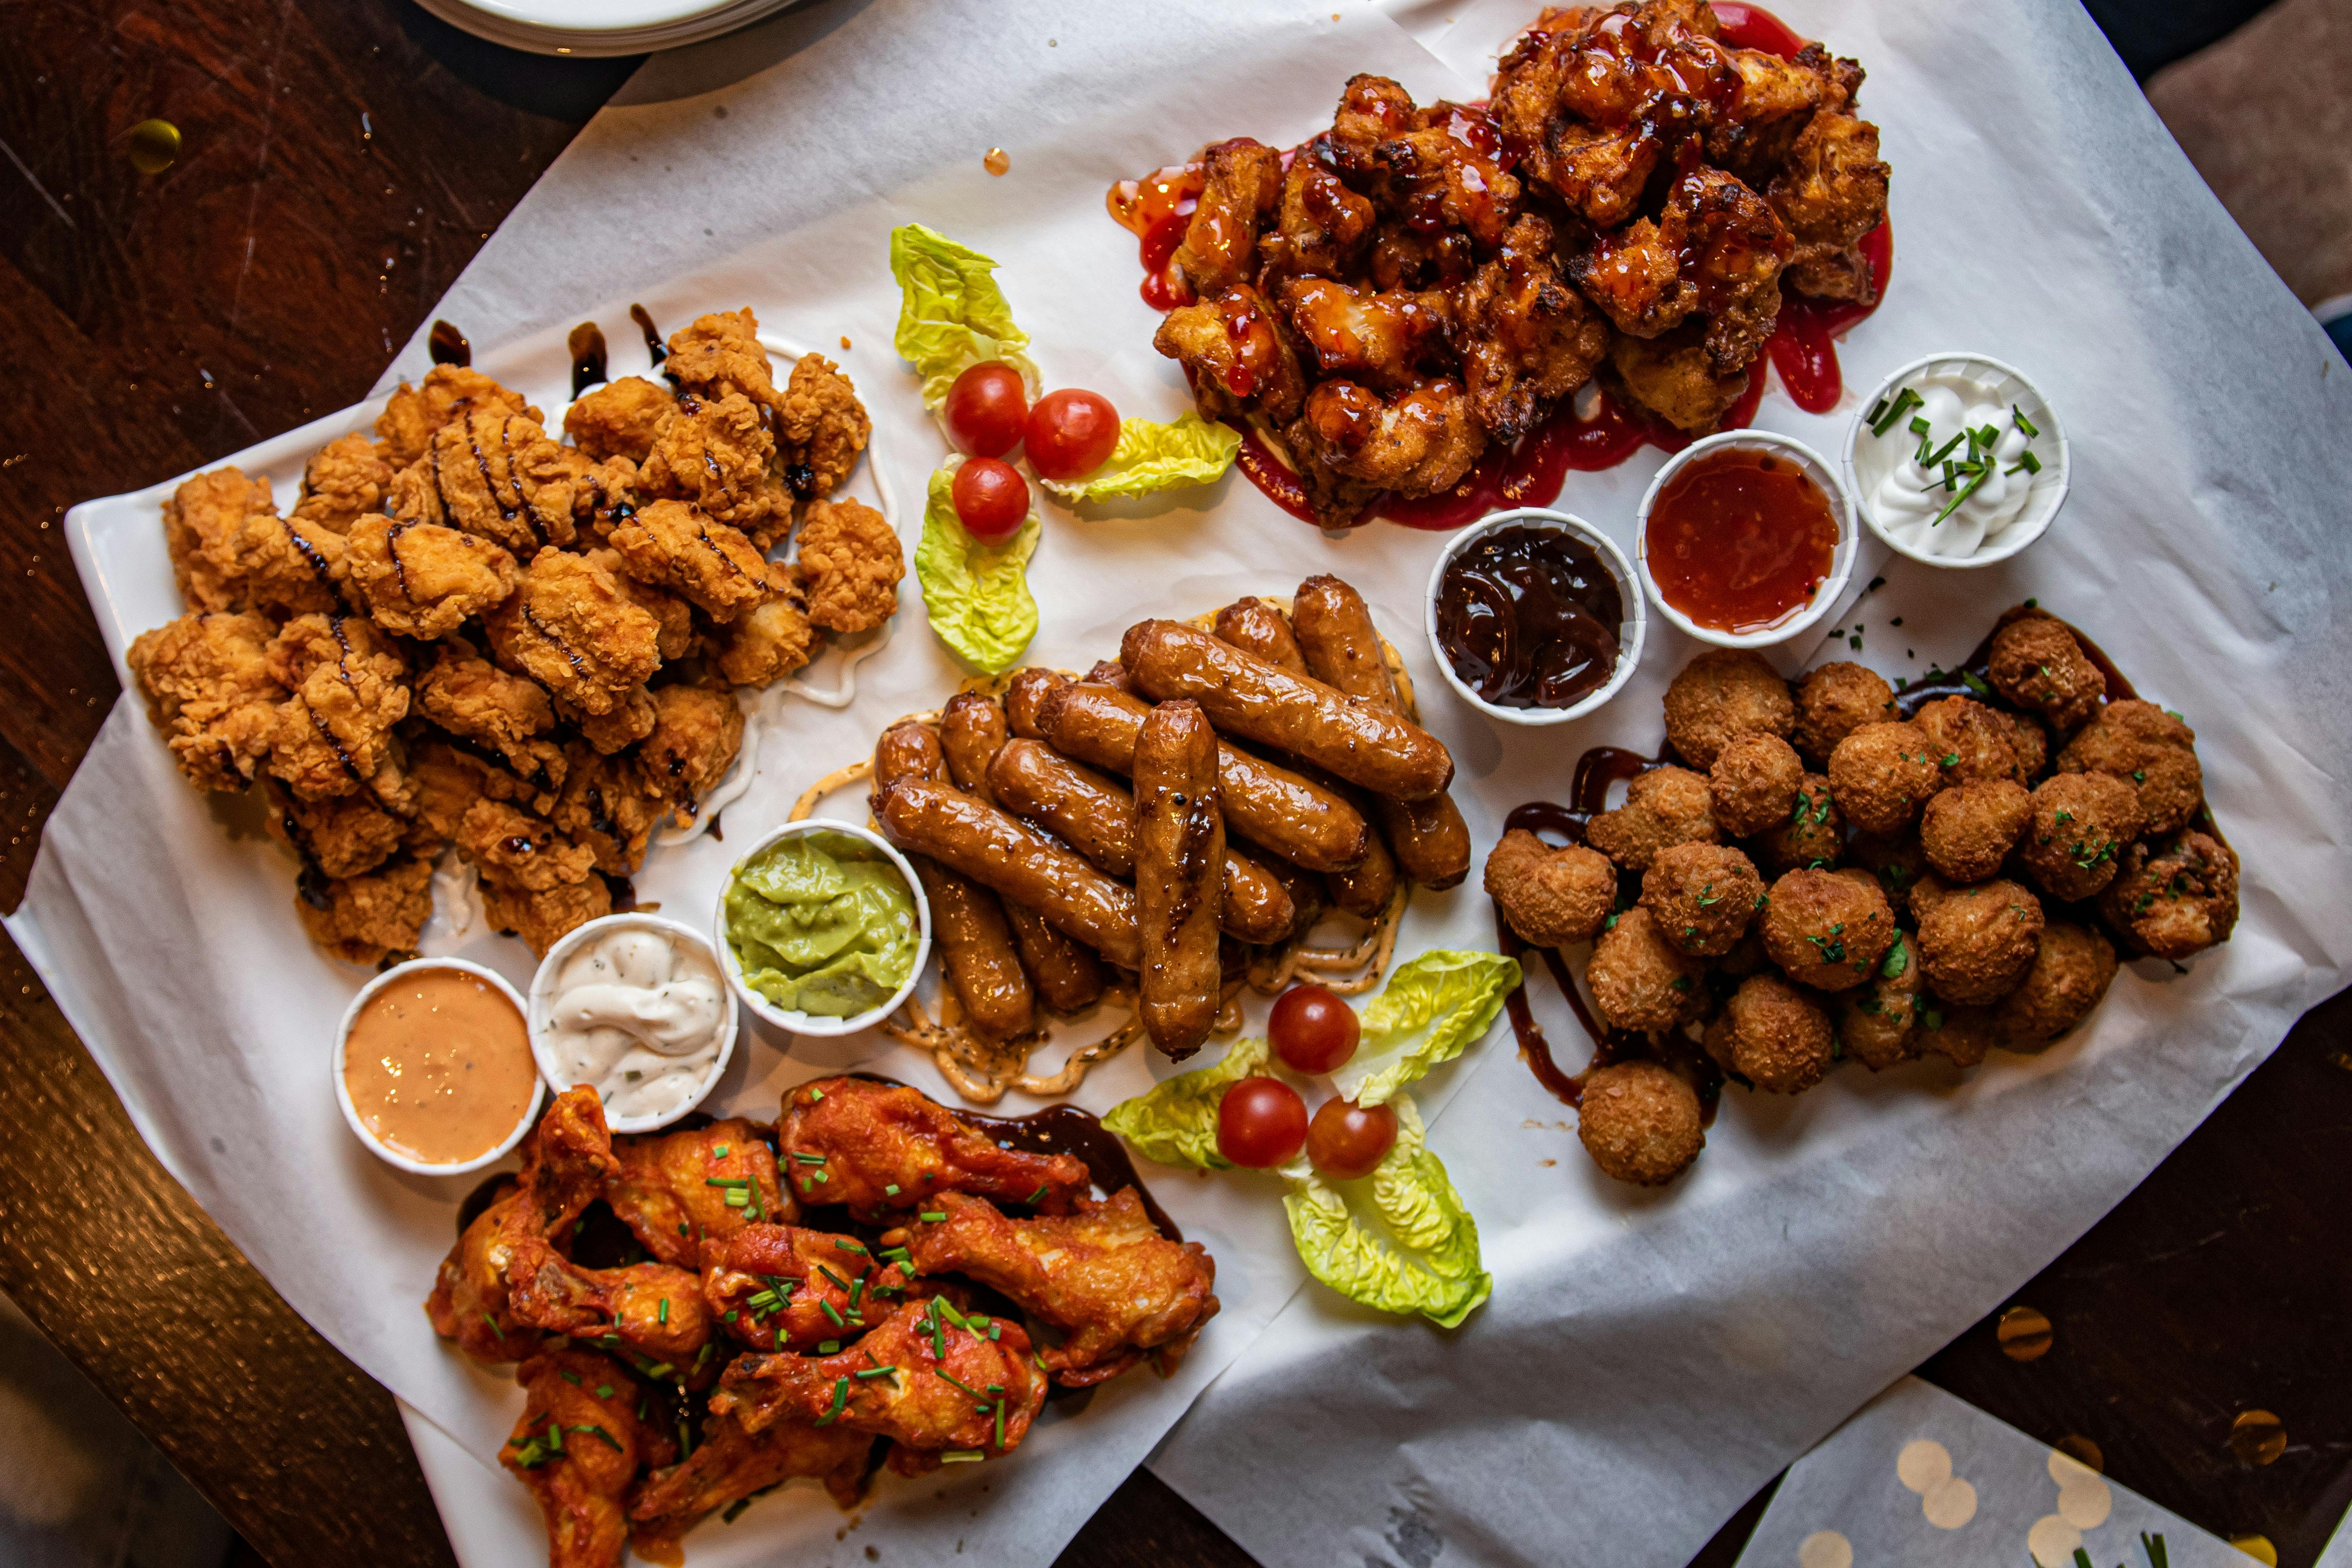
604;1117;800;1270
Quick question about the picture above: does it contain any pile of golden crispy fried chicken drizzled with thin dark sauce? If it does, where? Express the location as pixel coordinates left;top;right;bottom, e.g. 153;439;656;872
129;310;906;964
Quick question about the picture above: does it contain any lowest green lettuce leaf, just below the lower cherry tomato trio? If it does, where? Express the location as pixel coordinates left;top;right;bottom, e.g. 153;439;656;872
1282;1093;1494;1328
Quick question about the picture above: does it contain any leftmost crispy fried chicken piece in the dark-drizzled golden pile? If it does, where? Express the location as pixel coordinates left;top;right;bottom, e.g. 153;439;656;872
127;611;287;790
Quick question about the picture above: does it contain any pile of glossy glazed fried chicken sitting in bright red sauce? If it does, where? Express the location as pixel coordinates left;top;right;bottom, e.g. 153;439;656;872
1155;0;1889;527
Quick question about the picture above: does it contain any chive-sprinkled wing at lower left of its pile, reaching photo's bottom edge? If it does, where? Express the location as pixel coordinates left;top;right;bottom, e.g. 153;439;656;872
499;1349;675;1568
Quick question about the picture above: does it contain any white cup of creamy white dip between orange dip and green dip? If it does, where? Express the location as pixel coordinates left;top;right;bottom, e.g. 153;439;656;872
532;914;734;1131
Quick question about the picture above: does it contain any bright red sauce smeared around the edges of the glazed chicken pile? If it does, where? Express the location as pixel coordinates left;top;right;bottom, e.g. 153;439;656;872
1105;0;1893;531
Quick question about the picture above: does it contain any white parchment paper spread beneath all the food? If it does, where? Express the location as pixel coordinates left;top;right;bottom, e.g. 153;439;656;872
9;0;2352;1568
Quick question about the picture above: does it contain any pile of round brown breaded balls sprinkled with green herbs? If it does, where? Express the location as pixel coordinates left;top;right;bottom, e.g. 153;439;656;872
1486;607;2239;1185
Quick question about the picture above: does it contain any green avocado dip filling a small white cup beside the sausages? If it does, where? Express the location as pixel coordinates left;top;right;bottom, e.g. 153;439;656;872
727;832;918;1018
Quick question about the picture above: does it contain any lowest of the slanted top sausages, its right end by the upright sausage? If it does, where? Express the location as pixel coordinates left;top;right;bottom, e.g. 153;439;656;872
880;778;1143;969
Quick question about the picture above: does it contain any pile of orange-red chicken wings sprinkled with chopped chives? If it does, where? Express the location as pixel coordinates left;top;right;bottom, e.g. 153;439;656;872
426;1077;1218;1568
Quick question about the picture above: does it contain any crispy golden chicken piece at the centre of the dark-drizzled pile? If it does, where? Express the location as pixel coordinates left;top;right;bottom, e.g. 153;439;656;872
482;548;661;712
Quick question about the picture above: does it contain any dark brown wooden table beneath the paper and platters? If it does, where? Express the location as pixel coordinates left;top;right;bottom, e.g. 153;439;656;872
0;0;2352;1568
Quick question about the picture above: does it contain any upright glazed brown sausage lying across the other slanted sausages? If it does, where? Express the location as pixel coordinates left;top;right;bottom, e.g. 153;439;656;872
1136;700;1225;1060
